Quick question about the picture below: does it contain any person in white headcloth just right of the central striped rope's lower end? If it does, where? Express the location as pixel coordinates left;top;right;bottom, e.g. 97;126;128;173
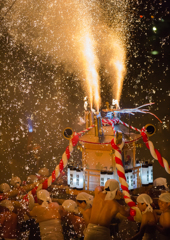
130;194;157;240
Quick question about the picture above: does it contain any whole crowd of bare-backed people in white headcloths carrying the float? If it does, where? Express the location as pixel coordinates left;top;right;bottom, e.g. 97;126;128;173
0;170;170;240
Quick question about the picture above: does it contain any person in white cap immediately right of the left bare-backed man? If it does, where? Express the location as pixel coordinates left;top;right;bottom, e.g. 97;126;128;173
62;200;86;240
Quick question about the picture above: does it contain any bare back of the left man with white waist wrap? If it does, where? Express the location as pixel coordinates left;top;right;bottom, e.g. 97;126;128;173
30;202;61;223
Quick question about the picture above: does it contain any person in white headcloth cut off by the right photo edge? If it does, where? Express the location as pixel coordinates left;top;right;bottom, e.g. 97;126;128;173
157;192;170;240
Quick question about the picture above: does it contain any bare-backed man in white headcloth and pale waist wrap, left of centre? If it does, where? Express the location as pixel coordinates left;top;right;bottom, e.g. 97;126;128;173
27;189;64;240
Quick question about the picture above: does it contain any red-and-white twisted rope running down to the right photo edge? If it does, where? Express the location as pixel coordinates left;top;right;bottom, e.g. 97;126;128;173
141;127;170;174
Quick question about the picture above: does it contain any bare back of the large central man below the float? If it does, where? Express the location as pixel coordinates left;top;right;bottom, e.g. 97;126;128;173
89;191;128;227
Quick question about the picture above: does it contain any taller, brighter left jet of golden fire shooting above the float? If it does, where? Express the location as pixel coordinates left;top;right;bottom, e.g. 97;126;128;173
82;32;101;112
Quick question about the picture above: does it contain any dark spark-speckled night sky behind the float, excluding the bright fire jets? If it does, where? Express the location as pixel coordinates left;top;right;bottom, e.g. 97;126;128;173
0;0;170;183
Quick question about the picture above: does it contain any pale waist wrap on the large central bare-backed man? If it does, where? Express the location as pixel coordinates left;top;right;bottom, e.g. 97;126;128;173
84;223;111;240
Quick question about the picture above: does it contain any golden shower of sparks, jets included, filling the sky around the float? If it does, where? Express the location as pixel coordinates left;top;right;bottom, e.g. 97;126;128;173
0;0;170;182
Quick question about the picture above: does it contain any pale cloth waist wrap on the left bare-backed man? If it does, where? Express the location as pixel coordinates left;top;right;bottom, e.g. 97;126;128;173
39;218;64;240
